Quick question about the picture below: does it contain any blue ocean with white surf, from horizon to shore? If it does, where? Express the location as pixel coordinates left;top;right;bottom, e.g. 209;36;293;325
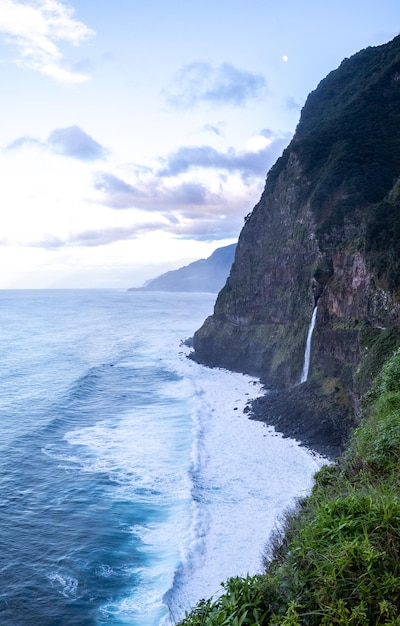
0;289;324;626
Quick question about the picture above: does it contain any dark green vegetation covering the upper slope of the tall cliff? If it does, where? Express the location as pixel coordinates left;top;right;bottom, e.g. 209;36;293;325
267;36;400;251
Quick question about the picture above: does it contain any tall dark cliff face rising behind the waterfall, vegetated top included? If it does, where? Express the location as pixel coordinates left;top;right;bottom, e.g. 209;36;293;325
194;37;400;424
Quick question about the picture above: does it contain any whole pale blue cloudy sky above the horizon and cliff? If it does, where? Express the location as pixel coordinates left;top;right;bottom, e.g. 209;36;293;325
0;0;400;289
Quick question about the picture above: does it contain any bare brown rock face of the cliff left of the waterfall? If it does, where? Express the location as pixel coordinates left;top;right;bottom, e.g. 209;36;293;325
195;154;320;384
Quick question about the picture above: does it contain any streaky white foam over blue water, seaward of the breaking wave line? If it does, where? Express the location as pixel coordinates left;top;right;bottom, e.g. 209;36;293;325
60;368;197;626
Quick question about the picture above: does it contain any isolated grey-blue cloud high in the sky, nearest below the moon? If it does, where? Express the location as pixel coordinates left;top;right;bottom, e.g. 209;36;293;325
164;62;266;108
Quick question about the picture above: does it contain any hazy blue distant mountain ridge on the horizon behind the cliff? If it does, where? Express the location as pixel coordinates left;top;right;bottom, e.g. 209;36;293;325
128;243;236;293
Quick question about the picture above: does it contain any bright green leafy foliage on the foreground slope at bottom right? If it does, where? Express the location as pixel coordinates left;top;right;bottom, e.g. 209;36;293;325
181;349;400;626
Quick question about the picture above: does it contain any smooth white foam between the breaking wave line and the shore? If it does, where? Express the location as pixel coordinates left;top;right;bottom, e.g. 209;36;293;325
162;348;325;624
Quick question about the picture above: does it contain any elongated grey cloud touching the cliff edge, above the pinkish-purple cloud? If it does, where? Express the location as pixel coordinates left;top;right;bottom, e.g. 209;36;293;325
158;134;289;178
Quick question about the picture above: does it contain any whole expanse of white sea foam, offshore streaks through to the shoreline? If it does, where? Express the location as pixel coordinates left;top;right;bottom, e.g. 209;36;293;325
53;348;324;626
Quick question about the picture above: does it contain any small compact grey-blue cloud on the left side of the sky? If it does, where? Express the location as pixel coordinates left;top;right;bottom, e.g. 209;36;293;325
47;126;107;161
